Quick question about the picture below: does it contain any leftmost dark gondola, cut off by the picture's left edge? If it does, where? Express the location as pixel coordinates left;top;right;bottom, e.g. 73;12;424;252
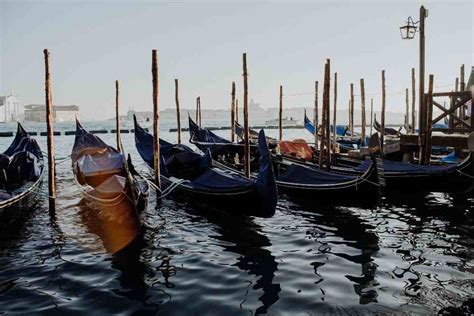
0;123;44;228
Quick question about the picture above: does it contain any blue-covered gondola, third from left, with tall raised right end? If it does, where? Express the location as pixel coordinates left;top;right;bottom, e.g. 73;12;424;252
134;117;278;217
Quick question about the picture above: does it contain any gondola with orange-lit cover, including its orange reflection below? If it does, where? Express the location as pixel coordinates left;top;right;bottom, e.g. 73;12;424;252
71;120;149;252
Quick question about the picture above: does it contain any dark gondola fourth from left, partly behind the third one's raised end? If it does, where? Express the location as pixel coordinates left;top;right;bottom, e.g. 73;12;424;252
189;118;379;202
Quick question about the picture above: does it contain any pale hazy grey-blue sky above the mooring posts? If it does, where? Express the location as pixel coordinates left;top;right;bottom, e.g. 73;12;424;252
0;0;474;120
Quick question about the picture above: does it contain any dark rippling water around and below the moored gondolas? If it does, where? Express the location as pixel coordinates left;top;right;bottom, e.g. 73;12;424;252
0;124;474;315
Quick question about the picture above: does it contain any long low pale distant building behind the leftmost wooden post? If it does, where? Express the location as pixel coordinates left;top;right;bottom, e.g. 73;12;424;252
25;104;80;122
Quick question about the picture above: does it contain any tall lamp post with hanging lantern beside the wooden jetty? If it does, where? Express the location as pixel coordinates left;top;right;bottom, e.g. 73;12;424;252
400;6;428;160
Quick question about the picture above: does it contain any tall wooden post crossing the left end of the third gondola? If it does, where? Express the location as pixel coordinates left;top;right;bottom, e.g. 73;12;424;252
151;49;161;191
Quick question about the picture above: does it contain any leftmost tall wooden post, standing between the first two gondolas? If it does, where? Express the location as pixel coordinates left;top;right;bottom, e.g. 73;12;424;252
43;49;56;213
